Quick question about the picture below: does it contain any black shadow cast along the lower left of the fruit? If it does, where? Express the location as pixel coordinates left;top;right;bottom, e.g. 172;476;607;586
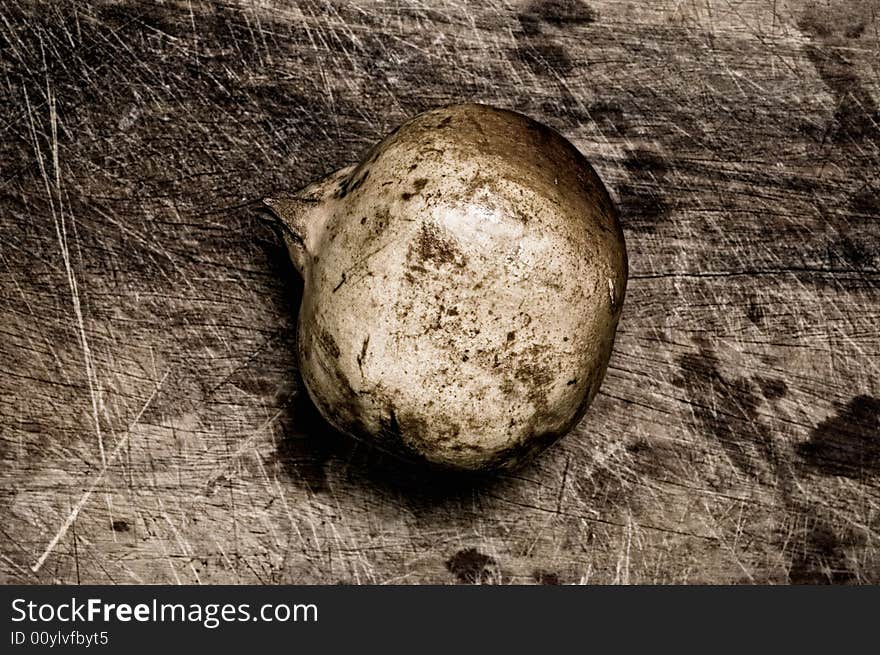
258;211;509;508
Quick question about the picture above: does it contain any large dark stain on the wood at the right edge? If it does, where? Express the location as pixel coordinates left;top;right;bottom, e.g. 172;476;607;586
797;395;880;480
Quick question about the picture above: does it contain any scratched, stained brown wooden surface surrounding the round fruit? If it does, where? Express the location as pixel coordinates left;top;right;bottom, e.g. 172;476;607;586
0;0;880;584
